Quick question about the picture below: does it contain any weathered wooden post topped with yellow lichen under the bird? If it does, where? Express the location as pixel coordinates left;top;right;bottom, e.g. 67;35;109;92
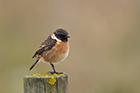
24;73;68;93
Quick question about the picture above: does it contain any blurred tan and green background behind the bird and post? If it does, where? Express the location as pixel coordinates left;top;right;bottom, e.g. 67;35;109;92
0;0;140;93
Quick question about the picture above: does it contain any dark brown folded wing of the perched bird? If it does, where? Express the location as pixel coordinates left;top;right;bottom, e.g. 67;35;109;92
32;36;57;58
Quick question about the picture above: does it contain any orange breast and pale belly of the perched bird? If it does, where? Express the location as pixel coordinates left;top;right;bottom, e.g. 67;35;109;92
43;42;69;63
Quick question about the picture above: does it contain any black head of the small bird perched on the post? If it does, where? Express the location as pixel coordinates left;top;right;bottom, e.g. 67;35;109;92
54;28;70;42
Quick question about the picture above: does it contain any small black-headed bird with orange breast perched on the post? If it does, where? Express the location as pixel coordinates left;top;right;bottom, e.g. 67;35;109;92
29;28;70;74
